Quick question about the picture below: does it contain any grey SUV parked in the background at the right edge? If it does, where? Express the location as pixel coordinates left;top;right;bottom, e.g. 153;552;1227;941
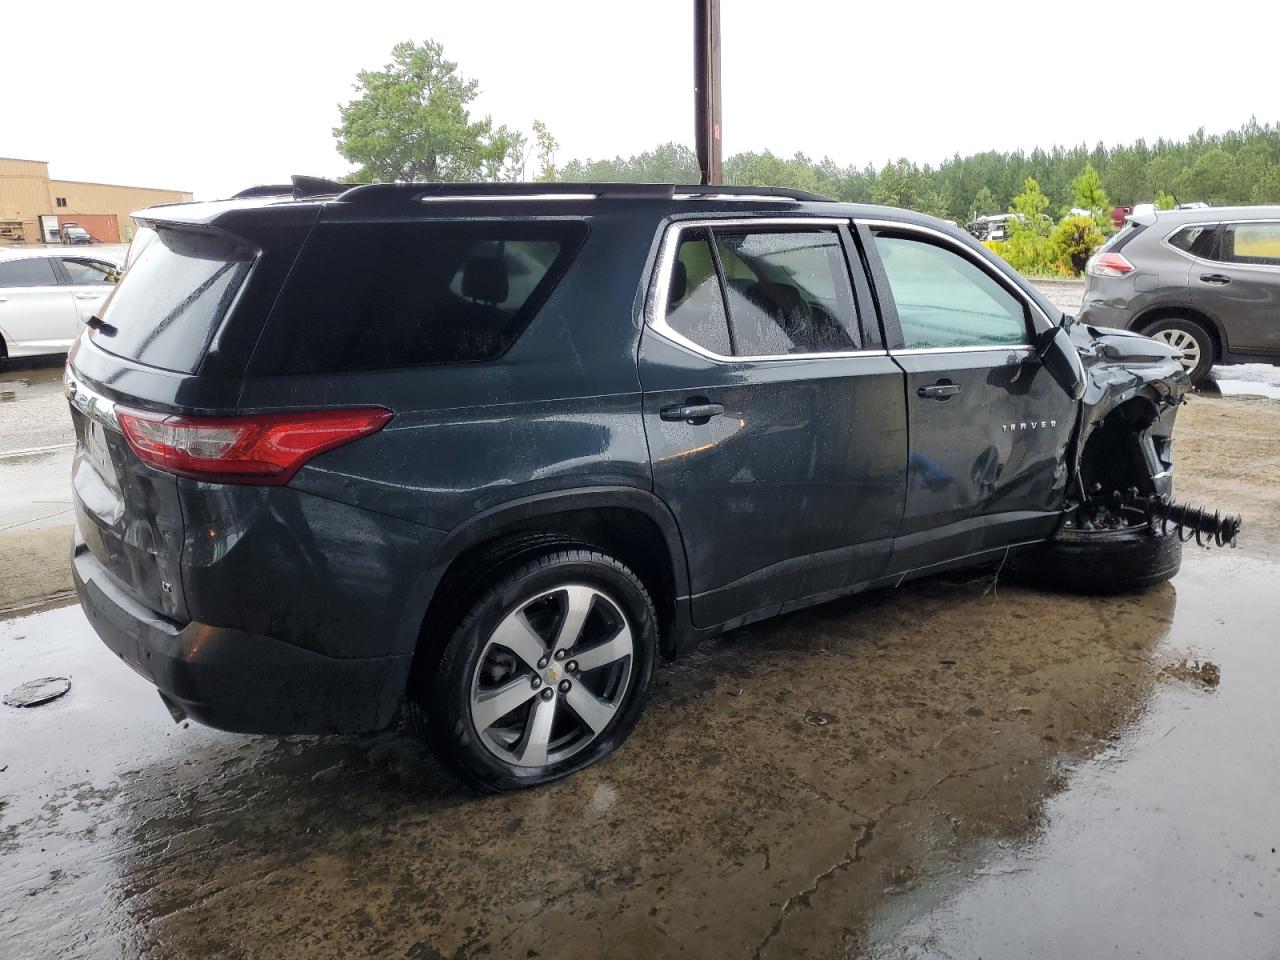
1080;206;1280;384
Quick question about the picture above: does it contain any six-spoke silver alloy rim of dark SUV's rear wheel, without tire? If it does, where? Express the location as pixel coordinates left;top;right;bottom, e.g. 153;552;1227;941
471;584;635;767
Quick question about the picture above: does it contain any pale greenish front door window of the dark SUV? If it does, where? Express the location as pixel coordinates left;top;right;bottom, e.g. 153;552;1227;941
876;237;1027;349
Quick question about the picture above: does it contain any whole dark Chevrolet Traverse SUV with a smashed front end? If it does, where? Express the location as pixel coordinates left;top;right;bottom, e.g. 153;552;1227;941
65;178;1188;790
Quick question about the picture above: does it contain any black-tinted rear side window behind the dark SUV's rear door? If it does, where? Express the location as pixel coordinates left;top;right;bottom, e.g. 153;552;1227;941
252;220;586;375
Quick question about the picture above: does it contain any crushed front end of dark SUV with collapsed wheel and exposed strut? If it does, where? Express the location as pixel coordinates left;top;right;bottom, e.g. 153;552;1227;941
1010;317;1240;593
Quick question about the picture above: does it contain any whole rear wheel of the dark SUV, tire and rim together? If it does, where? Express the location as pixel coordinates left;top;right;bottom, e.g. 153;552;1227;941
407;548;658;791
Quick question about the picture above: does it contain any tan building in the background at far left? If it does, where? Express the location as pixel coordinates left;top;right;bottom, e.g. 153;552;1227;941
0;157;192;243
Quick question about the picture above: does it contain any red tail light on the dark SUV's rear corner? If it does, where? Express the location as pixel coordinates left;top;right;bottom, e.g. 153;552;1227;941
116;407;392;486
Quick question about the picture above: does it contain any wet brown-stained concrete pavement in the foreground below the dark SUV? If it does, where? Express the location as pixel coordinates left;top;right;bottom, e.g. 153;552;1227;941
0;552;1280;959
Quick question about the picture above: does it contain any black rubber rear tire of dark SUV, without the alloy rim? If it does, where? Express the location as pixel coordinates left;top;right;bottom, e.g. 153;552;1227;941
422;549;658;791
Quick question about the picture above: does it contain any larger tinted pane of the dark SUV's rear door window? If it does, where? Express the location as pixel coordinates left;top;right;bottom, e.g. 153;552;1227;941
713;230;859;356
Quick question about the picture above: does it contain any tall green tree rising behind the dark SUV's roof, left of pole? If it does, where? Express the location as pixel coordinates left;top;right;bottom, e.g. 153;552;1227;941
333;40;525;182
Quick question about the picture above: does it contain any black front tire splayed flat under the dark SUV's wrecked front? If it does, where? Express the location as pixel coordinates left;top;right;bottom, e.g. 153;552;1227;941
1009;524;1183;595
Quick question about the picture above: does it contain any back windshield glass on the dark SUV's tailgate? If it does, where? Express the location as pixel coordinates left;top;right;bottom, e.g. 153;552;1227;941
90;228;253;374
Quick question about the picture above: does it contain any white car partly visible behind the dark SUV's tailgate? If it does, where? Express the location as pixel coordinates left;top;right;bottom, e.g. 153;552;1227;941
0;250;120;358
